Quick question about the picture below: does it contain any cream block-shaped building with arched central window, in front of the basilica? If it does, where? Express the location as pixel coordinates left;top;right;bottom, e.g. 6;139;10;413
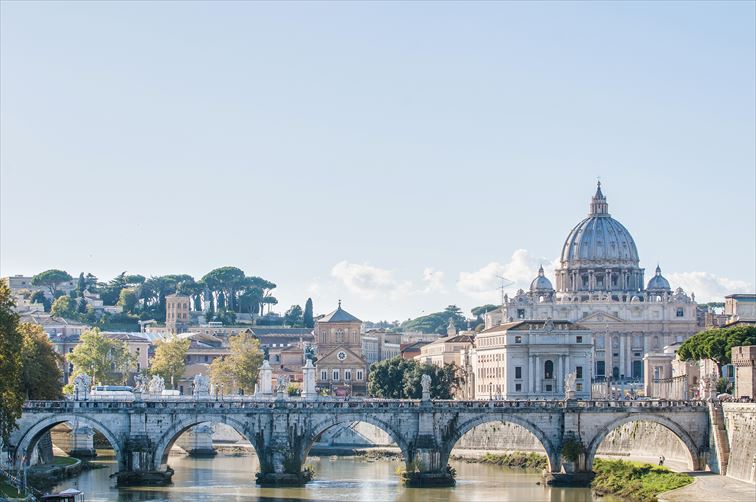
471;319;593;399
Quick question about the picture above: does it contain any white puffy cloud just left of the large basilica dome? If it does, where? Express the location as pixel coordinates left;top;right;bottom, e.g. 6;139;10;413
457;249;557;302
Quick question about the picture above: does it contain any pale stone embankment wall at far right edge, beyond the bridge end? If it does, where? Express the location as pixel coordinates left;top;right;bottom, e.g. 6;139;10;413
722;403;756;483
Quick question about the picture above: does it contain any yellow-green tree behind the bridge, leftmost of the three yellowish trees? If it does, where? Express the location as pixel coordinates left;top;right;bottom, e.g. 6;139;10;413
67;328;135;385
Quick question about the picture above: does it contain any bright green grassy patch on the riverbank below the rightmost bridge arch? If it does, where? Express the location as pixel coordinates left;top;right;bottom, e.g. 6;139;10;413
591;458;693;502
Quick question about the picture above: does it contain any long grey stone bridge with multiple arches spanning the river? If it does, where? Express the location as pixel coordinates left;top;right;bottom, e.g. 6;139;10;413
8;398;710;485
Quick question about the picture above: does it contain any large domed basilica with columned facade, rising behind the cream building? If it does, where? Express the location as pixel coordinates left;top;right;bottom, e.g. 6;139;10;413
485;183;697;380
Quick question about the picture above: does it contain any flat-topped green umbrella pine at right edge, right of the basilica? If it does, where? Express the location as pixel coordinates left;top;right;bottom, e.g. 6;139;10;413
677;326;756;375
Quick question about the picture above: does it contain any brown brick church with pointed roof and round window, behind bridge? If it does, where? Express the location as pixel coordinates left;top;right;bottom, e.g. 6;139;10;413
315;301;368;396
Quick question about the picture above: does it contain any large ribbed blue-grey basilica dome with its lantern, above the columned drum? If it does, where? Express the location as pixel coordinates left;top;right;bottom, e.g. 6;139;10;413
561;182;639;268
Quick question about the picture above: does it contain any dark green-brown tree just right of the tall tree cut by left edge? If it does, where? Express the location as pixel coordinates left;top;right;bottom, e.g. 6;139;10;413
18;322;63;399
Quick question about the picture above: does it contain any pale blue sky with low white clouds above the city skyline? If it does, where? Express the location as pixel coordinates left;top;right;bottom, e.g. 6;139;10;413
0;1;756;321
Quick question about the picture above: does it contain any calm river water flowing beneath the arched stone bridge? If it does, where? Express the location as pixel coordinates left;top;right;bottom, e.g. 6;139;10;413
50;451;619;502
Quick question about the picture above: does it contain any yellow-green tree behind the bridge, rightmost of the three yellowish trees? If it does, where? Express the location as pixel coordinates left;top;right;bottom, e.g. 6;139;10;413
210;333;263;394
